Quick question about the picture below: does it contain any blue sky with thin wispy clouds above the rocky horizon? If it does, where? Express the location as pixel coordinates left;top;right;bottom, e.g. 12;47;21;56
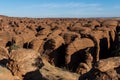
0;0;120;18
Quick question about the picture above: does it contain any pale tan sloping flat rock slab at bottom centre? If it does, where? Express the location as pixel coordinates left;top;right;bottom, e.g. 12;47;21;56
40;60;79;80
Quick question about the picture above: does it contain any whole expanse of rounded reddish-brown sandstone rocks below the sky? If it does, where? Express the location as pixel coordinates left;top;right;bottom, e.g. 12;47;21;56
0;16;120;80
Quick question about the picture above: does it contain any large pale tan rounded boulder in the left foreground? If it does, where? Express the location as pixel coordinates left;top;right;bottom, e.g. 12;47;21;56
7;49;43;79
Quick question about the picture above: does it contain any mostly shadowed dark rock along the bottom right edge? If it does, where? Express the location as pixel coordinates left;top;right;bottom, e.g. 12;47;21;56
79;69;119;80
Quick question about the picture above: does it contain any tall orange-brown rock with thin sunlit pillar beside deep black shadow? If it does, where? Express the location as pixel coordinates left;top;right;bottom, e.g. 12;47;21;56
82;30;110;61
